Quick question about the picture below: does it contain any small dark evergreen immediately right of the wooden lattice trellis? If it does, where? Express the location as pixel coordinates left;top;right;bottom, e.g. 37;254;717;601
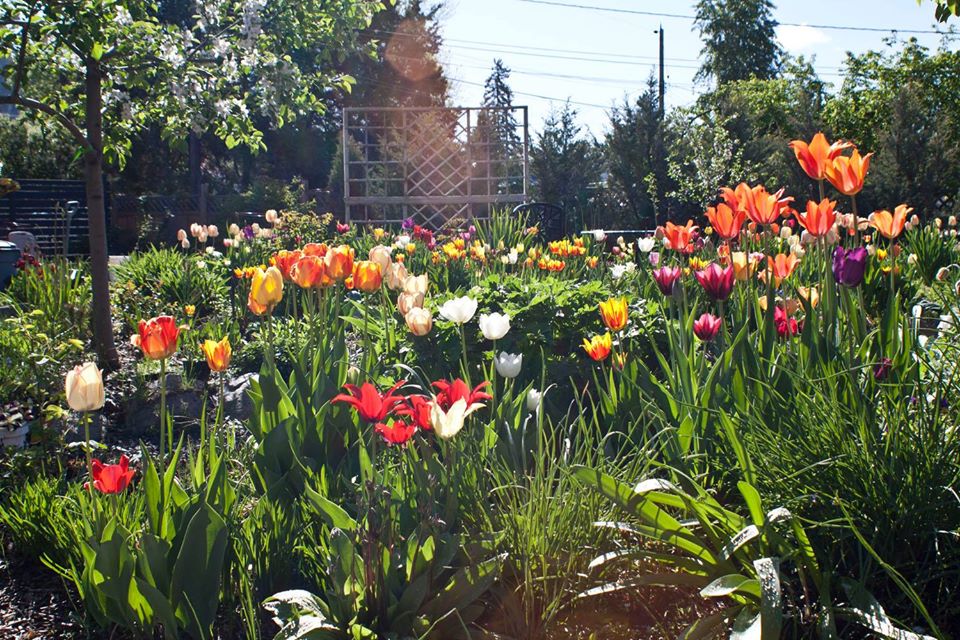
530;103;600;228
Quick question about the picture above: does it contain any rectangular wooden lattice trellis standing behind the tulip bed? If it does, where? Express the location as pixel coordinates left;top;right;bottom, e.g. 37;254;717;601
343;107;529;229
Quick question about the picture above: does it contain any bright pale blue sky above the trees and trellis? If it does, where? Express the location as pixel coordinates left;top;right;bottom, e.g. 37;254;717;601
441;0;958;136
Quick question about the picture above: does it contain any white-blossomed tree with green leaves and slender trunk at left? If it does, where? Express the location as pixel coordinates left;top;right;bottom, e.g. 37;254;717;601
0;0;392;364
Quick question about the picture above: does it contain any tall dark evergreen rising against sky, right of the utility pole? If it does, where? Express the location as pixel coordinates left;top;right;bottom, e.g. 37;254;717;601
694;0;783;85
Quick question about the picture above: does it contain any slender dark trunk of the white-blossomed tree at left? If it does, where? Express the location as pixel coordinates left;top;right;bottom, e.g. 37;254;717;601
83;59;120;369
